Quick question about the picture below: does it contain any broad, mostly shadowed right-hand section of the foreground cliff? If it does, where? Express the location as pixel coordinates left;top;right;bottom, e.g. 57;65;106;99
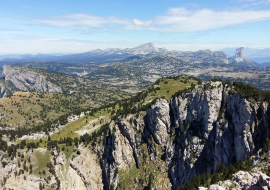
167;82;269;186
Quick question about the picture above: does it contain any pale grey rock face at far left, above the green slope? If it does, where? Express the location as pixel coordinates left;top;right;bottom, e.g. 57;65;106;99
3;65;62;93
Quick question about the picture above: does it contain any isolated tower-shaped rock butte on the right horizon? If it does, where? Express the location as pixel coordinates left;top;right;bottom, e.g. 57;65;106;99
229;47;259;67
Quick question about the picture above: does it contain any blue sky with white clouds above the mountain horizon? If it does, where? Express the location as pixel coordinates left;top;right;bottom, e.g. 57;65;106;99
0;0;270;55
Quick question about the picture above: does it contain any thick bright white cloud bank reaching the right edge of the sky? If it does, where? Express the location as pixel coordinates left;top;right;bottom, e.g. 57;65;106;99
149;8;270;32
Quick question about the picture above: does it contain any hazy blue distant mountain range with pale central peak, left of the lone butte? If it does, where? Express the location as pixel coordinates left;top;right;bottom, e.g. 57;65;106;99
0;42;228;67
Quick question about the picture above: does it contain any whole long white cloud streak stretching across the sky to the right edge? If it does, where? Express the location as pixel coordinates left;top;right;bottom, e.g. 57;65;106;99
34;7;270;32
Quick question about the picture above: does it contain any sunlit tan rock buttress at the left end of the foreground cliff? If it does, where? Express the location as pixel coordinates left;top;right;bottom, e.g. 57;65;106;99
97;116;143;189
